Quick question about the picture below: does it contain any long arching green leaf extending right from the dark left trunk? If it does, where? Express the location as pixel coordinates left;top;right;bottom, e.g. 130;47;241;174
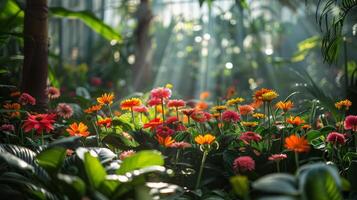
50;7;122;42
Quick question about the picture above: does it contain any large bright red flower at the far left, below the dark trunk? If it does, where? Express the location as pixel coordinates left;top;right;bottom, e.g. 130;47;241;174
22;114;56;134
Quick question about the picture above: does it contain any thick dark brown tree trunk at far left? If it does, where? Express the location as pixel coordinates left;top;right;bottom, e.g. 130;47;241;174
21;0;48;109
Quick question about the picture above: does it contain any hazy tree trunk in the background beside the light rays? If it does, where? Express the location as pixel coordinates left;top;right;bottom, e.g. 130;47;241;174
133;0;153;90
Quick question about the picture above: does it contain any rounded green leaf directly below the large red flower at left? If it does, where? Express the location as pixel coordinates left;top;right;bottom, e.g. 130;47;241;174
36;147;66;173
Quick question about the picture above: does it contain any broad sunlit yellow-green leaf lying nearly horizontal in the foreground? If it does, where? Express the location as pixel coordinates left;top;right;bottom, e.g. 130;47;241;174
117;150;164;174
